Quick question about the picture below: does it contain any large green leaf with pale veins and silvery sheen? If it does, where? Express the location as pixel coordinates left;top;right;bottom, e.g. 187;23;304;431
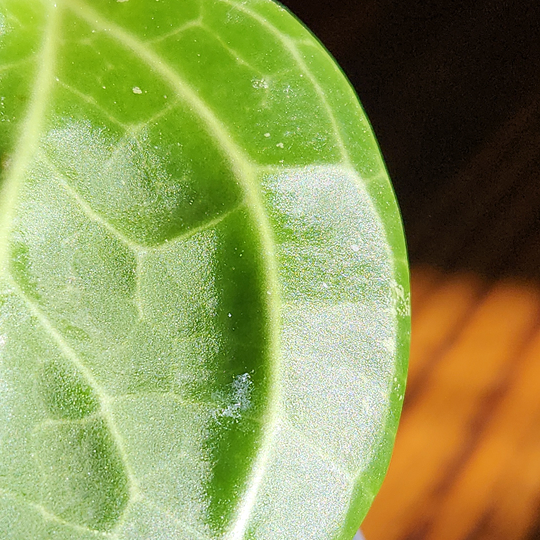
0;0;409;540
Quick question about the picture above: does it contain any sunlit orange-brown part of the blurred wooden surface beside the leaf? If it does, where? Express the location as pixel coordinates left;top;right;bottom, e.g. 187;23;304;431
363;267;540;540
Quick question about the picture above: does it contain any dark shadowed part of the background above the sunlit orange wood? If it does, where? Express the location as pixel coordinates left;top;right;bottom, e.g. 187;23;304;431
283;0;540;278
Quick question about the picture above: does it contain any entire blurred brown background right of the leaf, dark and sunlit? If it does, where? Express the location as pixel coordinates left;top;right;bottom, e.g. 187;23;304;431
283;0;540;540
